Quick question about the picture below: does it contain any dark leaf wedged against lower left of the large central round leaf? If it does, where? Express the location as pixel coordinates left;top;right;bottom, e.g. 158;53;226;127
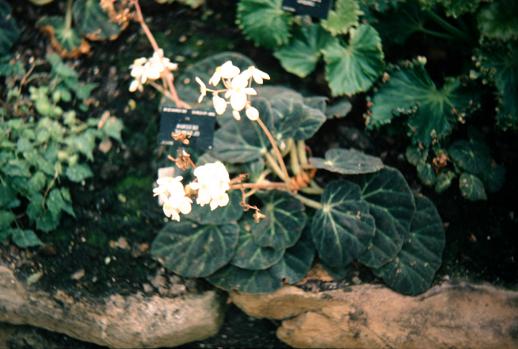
271;227;315;284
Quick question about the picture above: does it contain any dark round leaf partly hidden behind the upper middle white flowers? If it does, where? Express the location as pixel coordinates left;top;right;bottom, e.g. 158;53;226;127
176;52;254;106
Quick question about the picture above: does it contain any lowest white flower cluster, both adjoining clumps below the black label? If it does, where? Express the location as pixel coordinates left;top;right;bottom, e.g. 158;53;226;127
153;161;230;221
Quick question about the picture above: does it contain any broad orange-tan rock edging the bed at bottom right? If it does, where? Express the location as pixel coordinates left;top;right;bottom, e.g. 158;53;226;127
231;283;518;349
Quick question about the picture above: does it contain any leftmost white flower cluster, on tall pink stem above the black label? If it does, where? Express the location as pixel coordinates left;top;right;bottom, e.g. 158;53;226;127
129;50;178;92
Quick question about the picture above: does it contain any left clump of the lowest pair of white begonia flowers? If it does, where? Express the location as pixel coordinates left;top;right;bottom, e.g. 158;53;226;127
153;177;192;221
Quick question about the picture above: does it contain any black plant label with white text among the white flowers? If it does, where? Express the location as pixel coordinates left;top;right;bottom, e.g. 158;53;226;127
159;107;216;150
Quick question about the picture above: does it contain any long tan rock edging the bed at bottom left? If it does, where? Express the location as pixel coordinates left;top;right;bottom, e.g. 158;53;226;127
0;266;225;348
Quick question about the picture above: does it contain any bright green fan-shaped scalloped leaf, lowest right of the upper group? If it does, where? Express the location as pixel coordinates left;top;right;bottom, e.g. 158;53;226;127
323;24;384;96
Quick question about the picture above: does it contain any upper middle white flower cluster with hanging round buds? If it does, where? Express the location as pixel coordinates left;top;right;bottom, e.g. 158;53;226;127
196;61;270;121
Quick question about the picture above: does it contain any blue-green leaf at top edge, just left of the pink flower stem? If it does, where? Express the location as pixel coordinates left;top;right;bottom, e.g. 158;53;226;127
72;0;120;40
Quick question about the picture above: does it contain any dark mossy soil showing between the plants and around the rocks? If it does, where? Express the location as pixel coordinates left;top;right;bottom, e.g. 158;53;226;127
0;0;518;349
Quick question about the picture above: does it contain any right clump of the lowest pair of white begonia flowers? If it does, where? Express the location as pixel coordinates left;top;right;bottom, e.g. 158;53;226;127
190;161;230;210
